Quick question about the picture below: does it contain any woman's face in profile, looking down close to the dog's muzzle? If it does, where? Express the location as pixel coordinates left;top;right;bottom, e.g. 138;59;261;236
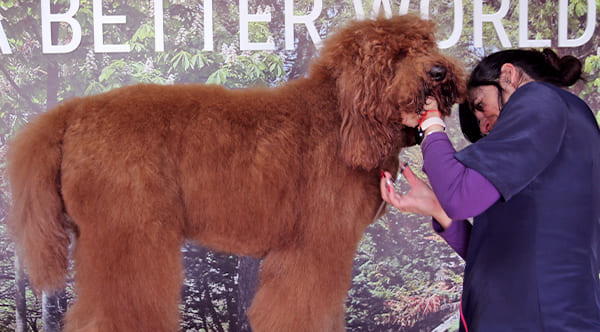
470;85;500;135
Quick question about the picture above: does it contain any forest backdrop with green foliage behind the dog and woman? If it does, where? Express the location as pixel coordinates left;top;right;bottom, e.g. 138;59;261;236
0;0;600;332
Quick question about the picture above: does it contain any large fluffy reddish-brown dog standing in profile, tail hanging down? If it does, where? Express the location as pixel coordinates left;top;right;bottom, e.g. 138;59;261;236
8;16;465;332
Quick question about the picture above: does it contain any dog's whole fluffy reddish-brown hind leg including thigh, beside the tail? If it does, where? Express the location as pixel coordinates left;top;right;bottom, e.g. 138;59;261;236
65;172;183;332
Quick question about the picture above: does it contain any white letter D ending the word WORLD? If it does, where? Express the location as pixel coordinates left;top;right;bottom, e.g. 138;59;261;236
558;0;596;47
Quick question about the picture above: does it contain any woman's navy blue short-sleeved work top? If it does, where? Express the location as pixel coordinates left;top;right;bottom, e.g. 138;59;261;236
455;82;600;332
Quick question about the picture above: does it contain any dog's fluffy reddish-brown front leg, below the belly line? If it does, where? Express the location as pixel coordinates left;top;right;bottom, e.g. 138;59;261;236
249;243;354;332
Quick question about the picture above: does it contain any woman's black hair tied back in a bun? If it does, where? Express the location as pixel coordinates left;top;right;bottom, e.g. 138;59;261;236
459;48;582;142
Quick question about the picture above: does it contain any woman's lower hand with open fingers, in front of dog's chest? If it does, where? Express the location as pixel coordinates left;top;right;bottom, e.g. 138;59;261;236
380;167;452;229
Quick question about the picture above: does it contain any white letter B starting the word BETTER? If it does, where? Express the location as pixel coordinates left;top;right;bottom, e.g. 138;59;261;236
41;0;81;53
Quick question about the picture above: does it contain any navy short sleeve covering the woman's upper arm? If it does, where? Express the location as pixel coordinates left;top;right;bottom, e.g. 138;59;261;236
454;82;569;201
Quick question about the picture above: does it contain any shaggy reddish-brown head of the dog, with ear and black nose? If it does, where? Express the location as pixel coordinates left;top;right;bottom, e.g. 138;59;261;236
313;15;466;170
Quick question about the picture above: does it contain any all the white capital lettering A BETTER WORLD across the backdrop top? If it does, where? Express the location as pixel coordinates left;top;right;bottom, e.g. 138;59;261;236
0;0;598;54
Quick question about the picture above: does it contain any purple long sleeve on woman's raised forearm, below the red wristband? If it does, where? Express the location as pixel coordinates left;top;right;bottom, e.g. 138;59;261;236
421;132;500;220
